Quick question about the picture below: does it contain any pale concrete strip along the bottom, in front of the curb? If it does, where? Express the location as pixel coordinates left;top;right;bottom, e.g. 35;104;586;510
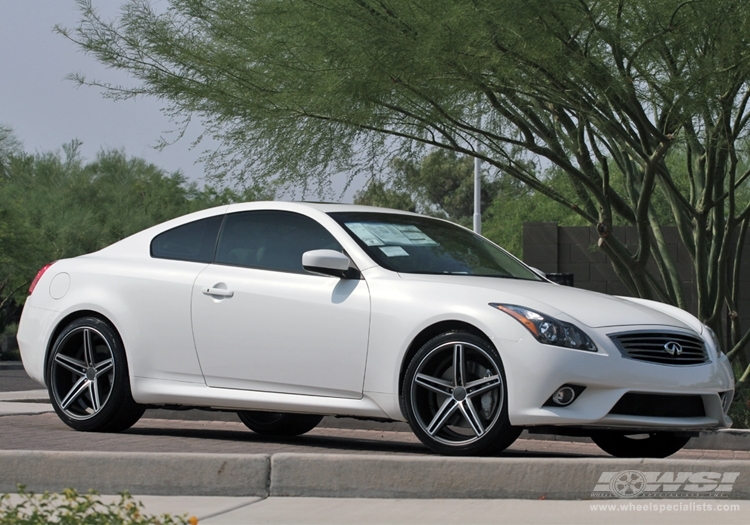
1;496;750;525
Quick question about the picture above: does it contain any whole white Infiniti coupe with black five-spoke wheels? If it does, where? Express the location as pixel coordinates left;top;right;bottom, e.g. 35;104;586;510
18;202;734;457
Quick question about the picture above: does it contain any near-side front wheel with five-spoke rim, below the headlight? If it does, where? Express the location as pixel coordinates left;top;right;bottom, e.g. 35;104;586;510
401;332;522;456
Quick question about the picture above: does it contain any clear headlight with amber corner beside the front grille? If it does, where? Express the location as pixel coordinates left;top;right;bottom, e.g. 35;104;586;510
490;303;596;352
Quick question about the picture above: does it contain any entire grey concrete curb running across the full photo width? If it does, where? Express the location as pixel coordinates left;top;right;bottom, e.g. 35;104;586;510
0;451;750;500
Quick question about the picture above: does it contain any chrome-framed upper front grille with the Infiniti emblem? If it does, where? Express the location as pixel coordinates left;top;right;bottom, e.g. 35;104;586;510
609;331;708;365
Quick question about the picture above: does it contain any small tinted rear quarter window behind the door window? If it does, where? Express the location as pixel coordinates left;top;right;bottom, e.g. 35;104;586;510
151;215;224;263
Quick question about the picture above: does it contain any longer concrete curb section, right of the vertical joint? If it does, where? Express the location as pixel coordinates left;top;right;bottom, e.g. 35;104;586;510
270;453;750;500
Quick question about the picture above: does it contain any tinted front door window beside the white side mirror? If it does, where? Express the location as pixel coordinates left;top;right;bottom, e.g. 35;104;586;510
216;211;341;273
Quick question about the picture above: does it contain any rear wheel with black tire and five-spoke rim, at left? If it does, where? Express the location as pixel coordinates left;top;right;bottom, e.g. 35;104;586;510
47;317;146;432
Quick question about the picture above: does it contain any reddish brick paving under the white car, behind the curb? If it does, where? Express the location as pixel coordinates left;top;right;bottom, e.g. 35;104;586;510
0;413;750;460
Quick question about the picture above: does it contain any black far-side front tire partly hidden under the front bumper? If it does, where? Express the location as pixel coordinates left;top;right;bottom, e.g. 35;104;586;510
591;432;690;458
